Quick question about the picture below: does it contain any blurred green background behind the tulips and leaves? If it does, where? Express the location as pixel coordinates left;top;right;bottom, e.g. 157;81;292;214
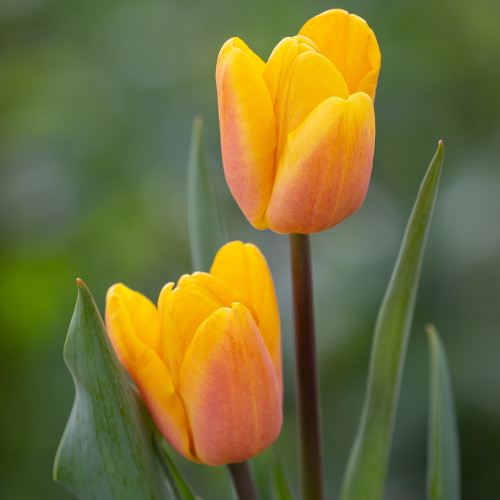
0;0;500;500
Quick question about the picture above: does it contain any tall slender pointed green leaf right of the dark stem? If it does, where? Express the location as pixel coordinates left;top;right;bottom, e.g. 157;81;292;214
341;141;443;500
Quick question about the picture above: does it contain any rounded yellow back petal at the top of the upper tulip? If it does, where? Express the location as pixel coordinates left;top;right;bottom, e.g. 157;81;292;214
299;9;380;99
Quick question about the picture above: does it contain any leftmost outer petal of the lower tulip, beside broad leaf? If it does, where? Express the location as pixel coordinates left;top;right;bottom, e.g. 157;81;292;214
106;285;199;462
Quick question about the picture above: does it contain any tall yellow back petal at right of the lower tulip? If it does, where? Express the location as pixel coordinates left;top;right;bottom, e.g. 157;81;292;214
210;241;282;387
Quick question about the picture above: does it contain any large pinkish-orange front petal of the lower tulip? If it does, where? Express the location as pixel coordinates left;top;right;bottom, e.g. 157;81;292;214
181;304;282;465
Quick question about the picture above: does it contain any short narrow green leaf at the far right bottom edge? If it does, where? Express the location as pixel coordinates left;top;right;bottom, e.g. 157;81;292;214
426;325;460;500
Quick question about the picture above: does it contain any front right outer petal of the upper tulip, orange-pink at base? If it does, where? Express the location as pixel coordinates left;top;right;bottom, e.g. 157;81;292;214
267;92;375;233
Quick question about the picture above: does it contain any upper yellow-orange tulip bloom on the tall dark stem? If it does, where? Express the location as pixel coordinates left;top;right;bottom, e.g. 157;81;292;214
216;10;380;234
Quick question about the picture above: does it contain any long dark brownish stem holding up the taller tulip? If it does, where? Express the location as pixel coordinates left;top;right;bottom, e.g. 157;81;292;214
290;234;324;500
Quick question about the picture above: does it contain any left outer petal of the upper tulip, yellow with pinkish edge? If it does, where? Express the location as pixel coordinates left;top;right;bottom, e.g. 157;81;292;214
216;38;276;228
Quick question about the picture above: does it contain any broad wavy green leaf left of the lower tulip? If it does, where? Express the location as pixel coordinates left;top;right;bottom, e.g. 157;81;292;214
54;280;169;500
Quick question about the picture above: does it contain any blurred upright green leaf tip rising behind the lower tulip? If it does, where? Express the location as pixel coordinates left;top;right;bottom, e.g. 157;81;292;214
188;117;227;272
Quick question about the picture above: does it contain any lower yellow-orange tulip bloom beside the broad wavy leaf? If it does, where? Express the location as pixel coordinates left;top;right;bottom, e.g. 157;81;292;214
106;242;283;465
